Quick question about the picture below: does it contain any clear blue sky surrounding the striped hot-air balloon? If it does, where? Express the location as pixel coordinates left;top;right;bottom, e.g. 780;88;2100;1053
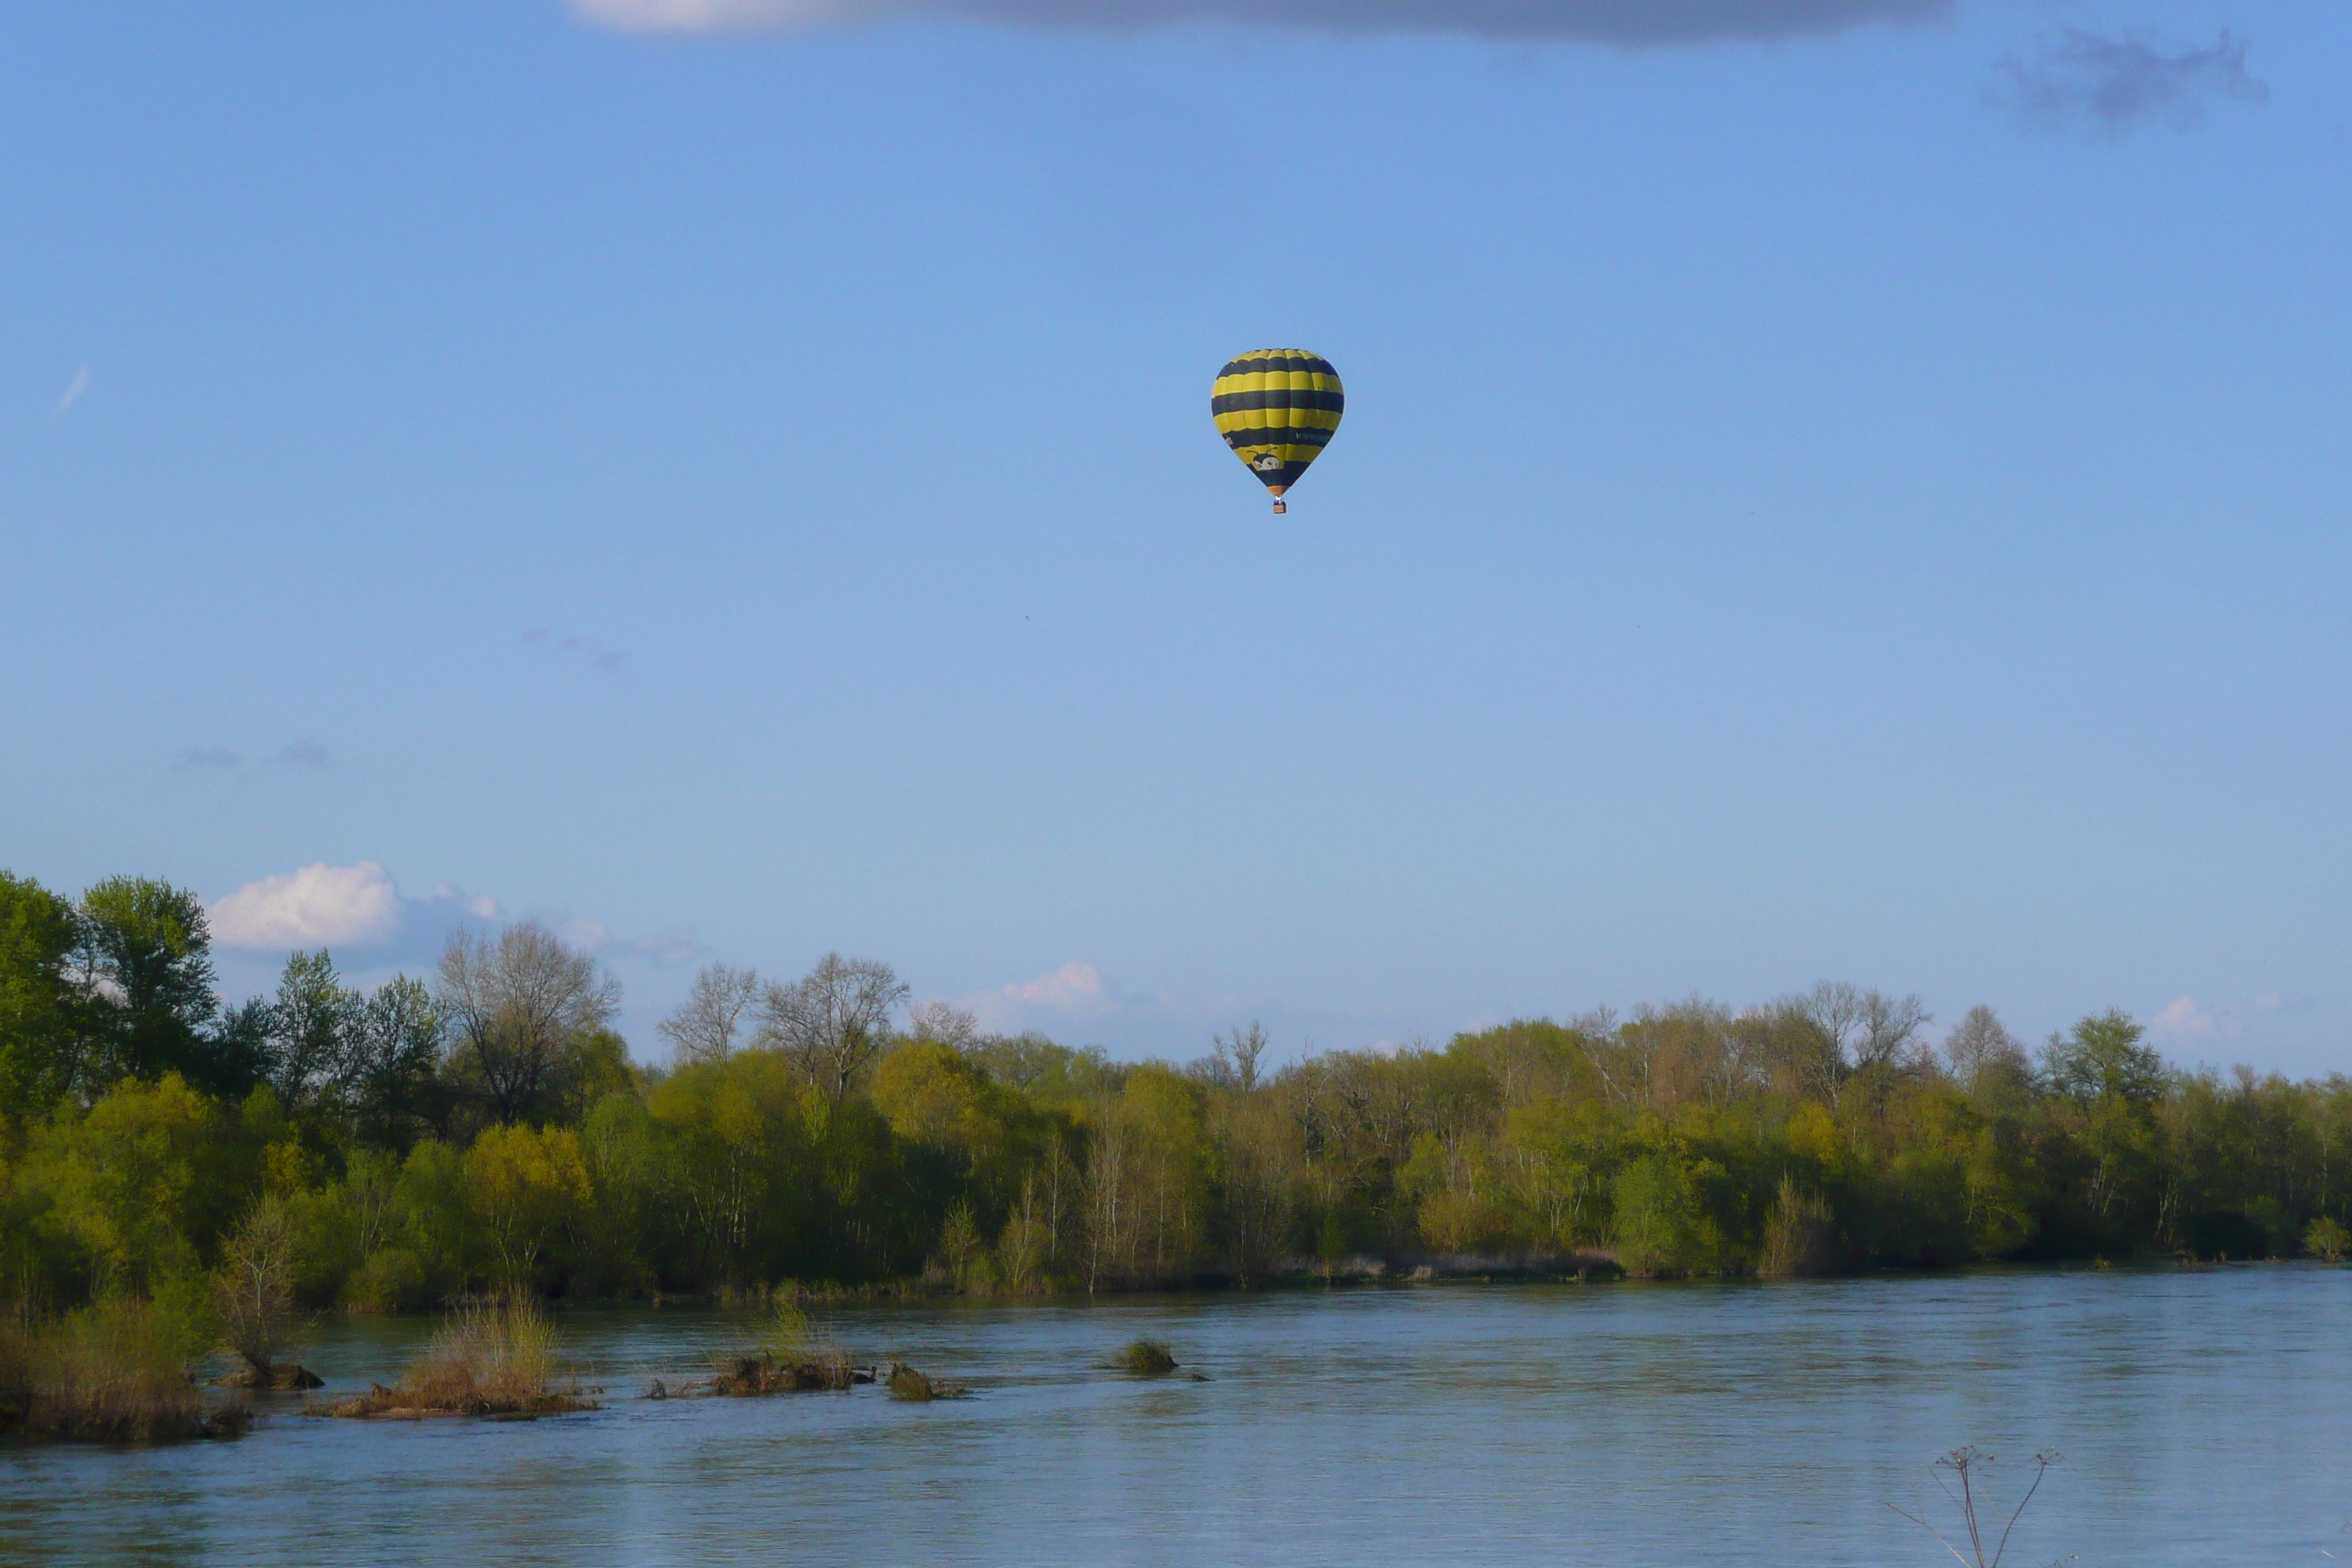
0;0;2352;1072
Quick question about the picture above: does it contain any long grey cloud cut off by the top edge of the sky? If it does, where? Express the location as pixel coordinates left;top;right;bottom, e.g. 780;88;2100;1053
571;0;1954;47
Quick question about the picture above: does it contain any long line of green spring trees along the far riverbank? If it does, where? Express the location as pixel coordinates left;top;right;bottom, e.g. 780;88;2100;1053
0;875;2352;1314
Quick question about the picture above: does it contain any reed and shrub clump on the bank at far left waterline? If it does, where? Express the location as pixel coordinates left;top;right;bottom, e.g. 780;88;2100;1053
0;1300;252;1444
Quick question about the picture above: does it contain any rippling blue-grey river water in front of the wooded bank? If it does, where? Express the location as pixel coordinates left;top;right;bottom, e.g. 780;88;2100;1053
0;1264;2352;1568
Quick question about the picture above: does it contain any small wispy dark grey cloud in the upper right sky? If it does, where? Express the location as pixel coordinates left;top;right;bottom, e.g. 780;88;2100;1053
1985;29;2269;136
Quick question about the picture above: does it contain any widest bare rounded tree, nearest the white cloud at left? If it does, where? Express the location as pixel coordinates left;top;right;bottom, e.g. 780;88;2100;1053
433;919;621;1121
